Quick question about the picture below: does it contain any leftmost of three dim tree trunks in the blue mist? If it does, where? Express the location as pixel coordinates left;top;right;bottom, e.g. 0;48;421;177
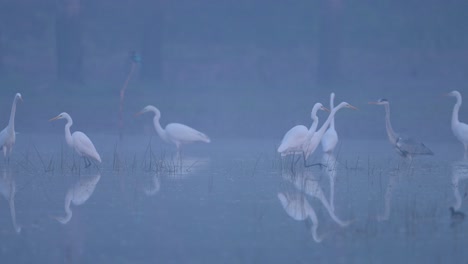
55;0;84;83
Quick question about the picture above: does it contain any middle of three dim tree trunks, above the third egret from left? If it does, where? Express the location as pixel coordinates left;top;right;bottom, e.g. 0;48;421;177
141;0;164;82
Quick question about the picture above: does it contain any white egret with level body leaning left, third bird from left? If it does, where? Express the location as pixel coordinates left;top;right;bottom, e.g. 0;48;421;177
136;105;211;157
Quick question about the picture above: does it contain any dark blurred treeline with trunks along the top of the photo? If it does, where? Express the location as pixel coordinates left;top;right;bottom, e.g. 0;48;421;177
0;0;468;87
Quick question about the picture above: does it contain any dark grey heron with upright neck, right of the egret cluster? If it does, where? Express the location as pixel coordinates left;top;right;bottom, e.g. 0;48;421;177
369;99;434;160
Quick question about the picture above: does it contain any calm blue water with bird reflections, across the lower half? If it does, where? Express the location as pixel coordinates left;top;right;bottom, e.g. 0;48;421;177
0;135;468;263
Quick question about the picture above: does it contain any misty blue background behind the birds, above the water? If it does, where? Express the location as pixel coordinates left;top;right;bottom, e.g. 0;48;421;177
0;0;468;141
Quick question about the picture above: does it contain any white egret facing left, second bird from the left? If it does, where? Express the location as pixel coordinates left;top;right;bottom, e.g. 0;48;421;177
49;112;101;168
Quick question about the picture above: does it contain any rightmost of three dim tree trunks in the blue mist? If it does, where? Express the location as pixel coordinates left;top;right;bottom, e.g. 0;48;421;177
317;0;343;85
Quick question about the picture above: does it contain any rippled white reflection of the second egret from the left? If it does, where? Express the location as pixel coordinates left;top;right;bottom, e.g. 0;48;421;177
54;173;101;224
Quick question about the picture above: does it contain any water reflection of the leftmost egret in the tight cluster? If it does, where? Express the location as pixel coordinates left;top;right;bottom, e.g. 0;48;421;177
278;192;323;243
